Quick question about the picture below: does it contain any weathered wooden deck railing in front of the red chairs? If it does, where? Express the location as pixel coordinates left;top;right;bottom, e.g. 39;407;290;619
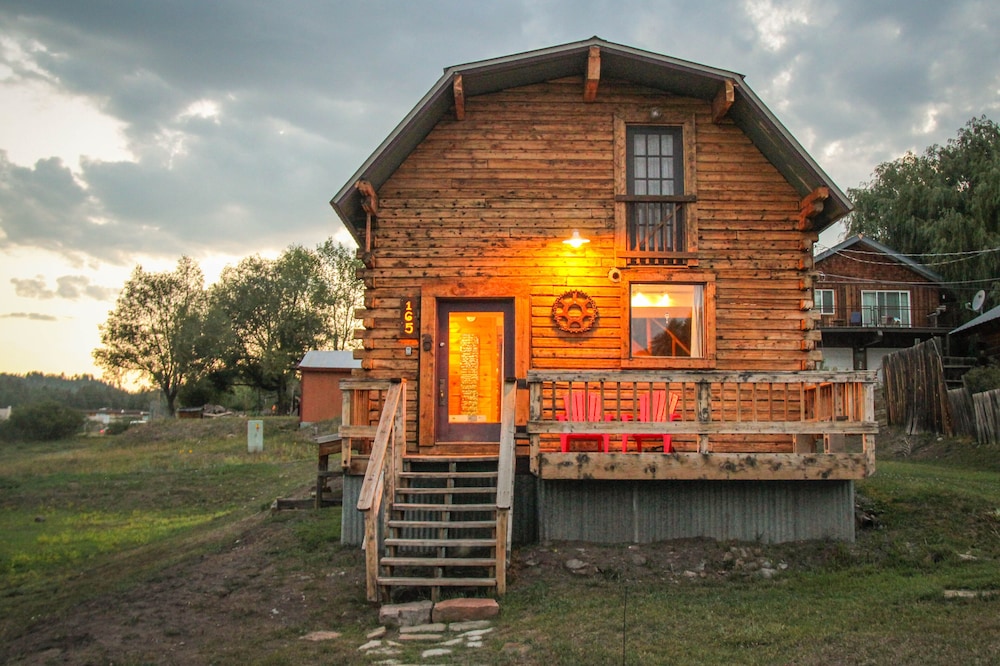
527;371;878;478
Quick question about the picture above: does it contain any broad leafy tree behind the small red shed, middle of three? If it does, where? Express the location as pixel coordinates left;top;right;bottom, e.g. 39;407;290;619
213;241;334;413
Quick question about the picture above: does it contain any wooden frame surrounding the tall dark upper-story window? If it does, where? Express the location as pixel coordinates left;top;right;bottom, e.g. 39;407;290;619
614;108;698;269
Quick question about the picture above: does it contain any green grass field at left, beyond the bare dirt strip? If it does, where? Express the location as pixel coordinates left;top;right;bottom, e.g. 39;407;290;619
0;419;315;643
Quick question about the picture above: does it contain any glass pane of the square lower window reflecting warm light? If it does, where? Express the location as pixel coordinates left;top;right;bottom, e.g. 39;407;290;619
629;284;705;358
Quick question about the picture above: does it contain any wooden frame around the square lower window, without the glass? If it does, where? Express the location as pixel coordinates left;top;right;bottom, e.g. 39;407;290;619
619;270;716;369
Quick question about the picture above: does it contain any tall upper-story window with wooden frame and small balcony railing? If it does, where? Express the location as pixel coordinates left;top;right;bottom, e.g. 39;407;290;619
615;117;696;266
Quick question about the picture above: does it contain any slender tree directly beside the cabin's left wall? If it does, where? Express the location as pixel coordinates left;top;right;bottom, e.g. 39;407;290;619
316;238;365;349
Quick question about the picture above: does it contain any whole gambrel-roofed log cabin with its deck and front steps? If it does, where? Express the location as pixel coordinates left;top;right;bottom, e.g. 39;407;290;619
331;37;877;600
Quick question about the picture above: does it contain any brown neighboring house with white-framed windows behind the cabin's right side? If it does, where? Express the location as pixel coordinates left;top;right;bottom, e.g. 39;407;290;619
813;235;958;371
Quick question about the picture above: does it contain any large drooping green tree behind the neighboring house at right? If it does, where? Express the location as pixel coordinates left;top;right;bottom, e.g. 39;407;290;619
848;116;1000;303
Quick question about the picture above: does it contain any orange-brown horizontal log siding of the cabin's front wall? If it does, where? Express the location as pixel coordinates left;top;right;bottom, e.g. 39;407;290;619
358;78;818;450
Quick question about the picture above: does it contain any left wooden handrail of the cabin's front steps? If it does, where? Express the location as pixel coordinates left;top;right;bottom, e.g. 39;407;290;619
357;379;406;601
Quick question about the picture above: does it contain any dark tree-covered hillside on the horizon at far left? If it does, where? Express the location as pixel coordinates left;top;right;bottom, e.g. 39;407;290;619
0;372;156;409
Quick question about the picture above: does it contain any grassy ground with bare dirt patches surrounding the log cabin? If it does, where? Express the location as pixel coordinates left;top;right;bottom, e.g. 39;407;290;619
0;419;1000;665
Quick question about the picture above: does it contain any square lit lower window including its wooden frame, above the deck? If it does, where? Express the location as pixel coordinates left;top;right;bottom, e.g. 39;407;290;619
623;281;715;367
